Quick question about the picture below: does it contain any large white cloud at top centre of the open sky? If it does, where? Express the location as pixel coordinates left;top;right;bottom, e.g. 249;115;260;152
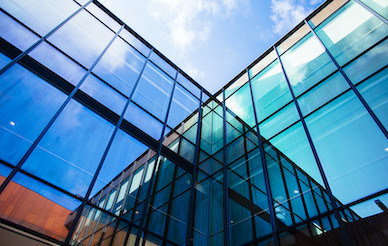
148;0;241;50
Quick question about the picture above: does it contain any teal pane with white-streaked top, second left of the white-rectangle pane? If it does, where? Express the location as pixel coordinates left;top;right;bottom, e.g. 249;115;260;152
252;61;292;122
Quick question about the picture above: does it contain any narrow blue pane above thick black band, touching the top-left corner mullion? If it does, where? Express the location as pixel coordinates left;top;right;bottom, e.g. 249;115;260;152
29;42;86;86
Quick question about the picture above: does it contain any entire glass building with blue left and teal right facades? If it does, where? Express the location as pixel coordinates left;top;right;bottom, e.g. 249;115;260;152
0;0;388;246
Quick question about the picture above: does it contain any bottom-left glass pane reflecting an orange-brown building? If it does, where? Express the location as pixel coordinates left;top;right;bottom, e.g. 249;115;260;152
0;173;81;241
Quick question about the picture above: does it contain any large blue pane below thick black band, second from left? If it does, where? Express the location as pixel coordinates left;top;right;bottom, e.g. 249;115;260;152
23;101;114;196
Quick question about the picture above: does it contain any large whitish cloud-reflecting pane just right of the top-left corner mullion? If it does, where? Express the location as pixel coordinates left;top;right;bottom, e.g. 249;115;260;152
48;10;114;68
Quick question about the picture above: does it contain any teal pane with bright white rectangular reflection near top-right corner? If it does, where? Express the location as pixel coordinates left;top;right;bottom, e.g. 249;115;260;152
316;1;388;66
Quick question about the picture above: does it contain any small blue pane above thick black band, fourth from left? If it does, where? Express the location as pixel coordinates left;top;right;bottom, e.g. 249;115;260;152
124;103;163;139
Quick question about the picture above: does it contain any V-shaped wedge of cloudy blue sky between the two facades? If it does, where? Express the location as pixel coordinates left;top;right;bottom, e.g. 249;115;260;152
101;0;324;93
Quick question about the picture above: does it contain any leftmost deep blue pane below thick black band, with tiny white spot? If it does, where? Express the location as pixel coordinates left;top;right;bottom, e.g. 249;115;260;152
0;65;66;165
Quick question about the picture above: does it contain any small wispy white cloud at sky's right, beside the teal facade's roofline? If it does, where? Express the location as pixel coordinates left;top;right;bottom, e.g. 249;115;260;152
270;0;316;34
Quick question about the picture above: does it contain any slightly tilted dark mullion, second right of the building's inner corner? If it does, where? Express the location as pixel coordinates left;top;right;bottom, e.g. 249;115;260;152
247;69;280;246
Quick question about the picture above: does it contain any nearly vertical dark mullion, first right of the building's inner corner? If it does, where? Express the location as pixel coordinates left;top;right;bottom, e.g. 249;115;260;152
221;89;231;246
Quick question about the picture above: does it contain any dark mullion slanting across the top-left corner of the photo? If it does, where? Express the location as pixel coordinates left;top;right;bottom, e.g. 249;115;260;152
0;0;93;75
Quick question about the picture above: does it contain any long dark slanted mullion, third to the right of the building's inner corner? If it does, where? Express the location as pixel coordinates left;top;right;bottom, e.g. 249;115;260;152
273;45;352;246
